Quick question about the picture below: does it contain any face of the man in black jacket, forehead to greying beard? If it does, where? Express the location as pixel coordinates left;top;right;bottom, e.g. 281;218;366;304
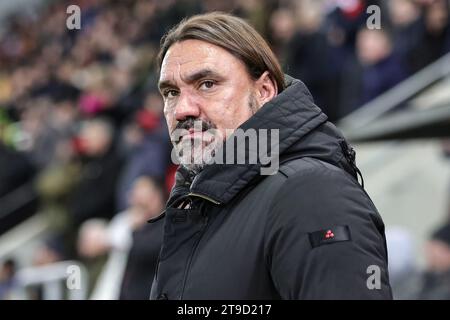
159;40;259;170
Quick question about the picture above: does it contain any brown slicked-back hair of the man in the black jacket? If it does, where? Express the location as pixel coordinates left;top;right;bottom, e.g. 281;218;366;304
158;12;285;92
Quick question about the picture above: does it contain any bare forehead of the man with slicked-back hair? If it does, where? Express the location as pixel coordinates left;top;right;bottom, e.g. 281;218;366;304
160;40;245;81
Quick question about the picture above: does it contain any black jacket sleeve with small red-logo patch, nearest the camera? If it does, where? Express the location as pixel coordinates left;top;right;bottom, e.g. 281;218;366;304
265;163;392;299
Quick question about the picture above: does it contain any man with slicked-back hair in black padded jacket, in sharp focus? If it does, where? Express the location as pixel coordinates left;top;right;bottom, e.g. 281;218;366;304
151;13;391;299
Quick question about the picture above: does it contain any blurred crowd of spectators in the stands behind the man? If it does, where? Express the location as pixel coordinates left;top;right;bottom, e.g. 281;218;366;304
0;0;450;299
